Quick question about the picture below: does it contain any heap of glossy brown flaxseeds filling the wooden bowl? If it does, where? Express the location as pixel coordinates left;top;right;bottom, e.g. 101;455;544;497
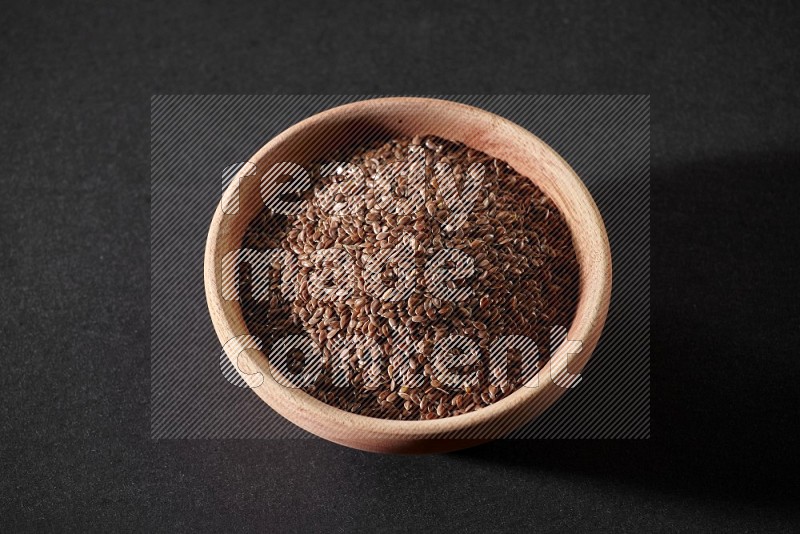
242;136;577;420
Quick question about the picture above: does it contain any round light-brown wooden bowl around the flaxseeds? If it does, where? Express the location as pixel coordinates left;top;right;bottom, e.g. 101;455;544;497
205;98;611;453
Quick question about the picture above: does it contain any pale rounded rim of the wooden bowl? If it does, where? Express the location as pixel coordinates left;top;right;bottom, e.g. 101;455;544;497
204;97;611;449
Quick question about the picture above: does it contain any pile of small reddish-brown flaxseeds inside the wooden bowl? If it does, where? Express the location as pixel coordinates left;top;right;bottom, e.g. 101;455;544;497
241;137;579;420
